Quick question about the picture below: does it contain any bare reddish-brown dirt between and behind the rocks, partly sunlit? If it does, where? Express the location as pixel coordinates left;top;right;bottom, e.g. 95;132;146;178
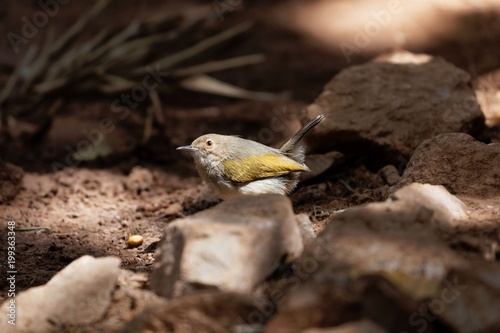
0;0;500;330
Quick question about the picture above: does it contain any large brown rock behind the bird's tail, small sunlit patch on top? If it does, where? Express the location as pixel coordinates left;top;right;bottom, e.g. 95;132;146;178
304;50;484;168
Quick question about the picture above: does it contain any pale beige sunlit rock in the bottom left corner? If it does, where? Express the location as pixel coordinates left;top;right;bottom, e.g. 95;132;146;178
0;256;120;333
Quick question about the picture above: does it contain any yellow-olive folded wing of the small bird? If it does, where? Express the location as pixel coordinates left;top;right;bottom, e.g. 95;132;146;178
222;154;309;183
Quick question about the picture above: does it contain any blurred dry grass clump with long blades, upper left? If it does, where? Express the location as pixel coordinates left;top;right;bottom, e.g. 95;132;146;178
0;0;274;132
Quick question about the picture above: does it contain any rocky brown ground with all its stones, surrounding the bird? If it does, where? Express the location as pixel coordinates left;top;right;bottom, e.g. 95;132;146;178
0;0;500;333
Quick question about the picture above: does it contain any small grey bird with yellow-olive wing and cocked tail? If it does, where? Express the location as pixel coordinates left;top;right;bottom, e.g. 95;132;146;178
177;115;325;199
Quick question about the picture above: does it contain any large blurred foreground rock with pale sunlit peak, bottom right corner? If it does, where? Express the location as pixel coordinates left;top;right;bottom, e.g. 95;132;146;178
264;179;500;333
